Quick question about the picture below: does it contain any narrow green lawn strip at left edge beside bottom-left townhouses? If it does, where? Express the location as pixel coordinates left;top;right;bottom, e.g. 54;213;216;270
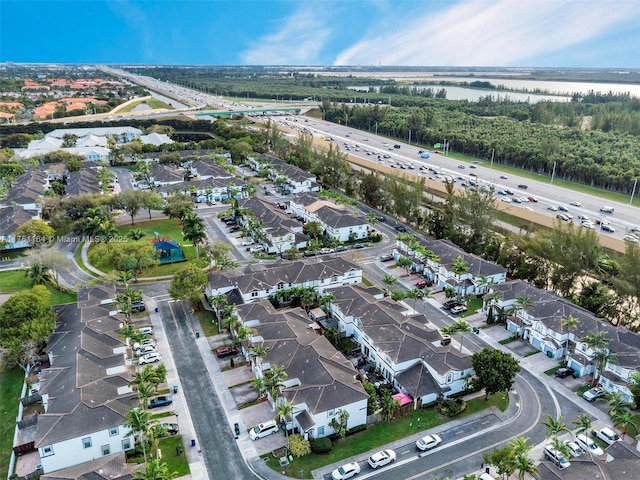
0;365;24;474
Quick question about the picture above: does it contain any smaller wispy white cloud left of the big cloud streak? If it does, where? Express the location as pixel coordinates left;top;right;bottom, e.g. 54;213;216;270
240;5;331;65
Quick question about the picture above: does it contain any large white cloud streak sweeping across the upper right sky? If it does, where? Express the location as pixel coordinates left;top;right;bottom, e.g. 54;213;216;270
334;0;640;66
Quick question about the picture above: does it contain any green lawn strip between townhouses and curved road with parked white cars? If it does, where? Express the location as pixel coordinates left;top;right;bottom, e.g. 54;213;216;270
267;393;509;478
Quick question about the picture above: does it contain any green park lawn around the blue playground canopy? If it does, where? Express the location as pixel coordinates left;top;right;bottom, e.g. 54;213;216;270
89;218;196;279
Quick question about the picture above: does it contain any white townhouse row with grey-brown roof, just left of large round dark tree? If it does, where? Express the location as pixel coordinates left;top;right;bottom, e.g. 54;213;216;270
330;285;473;408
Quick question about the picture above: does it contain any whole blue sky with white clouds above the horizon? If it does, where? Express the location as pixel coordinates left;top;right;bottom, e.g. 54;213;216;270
0;0;640;68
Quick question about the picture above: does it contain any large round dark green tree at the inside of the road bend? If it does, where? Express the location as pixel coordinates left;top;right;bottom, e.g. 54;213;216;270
471;347;520;400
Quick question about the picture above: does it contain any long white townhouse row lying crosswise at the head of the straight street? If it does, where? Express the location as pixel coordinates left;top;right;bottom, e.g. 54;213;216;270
205;255;362;303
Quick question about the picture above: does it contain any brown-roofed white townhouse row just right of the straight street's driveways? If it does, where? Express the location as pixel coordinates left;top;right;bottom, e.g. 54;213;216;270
237;300;369;438
